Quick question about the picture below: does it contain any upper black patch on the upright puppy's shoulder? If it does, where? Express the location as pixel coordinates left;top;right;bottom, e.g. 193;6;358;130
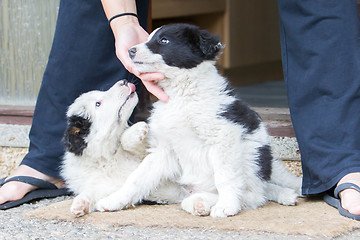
219;100;261;133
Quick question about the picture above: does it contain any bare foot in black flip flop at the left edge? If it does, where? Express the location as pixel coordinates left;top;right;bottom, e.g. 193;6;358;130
0;165;65;204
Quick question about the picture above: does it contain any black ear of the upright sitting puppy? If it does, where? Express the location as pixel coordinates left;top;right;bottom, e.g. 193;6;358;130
199;30;223;60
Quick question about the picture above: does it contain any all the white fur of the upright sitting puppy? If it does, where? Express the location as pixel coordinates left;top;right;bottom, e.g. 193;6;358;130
96;25;301;217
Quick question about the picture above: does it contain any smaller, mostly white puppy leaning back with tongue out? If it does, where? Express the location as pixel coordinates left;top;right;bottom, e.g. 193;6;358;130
61;81;182;217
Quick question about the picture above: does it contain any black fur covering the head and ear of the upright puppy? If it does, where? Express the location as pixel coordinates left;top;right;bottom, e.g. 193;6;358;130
146;24;222;69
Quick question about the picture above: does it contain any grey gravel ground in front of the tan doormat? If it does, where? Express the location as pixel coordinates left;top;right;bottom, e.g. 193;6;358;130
0;197;360;240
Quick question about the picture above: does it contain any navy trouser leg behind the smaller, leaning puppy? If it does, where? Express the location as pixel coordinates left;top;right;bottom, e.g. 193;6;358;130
22;0;149;178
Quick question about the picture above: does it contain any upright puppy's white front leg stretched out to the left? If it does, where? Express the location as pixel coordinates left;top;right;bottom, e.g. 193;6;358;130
95;151;174;211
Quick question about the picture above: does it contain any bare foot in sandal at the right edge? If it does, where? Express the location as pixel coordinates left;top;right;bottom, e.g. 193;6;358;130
338;172;360;215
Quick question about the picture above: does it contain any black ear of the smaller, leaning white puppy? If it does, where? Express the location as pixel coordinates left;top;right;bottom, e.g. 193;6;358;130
63;116;91;156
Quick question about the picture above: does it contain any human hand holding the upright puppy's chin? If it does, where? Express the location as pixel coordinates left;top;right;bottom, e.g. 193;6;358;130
111;16;169;102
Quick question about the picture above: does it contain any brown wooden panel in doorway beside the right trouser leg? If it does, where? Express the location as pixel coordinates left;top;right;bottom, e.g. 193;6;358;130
223;0;281;69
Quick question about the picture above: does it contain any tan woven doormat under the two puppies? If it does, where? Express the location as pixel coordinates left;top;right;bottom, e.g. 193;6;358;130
25;199;360;238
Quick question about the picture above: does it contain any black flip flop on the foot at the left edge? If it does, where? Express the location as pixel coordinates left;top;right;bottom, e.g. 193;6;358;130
0;176;72;210
